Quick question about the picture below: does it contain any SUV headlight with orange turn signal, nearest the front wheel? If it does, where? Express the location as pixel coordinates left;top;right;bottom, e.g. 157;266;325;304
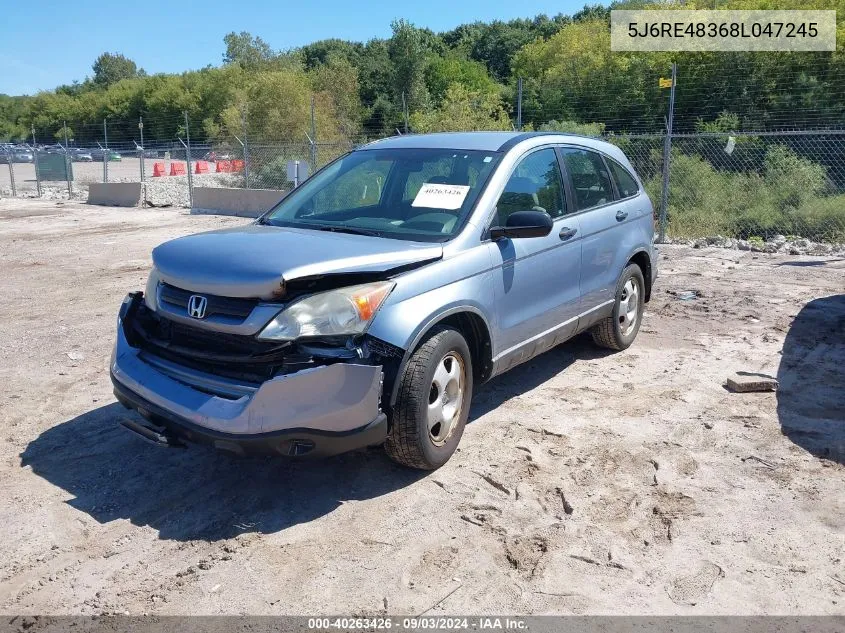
258;281;396;341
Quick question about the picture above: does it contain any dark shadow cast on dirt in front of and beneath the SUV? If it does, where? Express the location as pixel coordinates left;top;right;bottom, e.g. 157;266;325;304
20;337;606;541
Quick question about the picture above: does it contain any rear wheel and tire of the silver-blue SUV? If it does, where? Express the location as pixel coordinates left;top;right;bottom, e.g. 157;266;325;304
591;264;645;351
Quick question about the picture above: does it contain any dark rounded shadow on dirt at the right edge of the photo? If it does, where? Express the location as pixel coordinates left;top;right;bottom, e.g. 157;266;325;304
777;295;845;464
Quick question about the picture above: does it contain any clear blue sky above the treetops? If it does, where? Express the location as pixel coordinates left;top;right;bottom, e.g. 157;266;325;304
0;0;595;95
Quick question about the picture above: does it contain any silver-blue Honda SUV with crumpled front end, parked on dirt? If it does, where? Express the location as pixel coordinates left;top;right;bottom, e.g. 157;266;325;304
111;132;657;469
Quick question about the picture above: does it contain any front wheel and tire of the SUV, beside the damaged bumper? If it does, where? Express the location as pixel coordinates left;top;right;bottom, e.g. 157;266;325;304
384;327;472;470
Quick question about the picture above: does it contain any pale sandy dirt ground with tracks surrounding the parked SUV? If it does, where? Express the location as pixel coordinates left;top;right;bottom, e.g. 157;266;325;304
0;200;845;615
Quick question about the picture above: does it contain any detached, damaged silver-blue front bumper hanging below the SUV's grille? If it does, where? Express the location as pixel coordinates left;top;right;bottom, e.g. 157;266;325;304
110;297;387;456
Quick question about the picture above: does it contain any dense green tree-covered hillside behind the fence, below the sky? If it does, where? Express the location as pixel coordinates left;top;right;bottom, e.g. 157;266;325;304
0;0;845;144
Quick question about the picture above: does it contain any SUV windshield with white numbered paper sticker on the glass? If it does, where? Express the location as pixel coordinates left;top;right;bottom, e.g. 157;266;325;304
262;149;499;241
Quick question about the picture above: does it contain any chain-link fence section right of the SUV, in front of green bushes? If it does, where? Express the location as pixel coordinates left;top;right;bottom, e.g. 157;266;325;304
607;131;845;244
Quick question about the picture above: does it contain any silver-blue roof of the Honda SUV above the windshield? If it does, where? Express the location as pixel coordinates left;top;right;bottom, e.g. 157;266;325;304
360;132;614;152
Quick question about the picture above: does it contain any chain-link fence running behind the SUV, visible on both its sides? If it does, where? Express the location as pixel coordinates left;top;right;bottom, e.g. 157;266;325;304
0;112;845;244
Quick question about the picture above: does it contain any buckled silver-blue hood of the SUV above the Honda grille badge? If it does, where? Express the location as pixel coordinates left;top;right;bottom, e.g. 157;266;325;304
153;224;443;300
